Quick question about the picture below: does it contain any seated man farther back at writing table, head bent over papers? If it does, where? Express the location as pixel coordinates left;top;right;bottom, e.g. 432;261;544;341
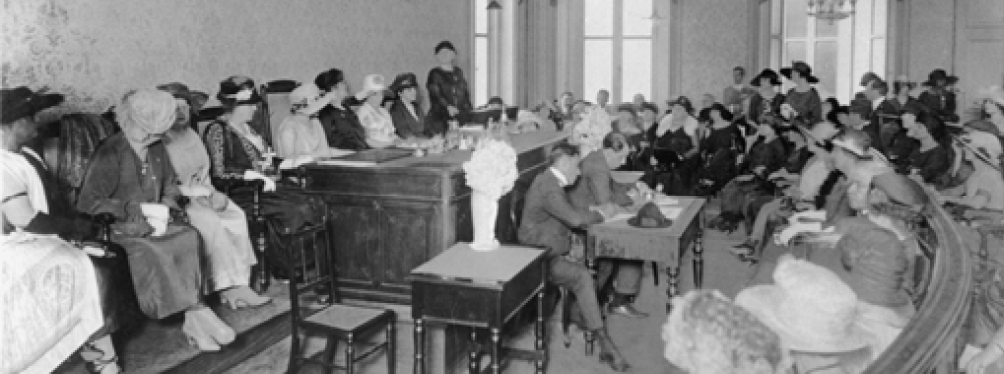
568;132;648;318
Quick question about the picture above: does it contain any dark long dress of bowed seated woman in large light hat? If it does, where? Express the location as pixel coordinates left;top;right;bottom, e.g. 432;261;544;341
76;132;203;319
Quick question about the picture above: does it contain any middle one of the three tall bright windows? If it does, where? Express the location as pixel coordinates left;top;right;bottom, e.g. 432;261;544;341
582;0;655;102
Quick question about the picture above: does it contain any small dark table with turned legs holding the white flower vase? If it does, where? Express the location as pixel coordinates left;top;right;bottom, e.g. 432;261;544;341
411;243;547;374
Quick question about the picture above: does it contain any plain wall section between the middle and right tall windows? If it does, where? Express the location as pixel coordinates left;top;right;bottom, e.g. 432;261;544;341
673;0;756;101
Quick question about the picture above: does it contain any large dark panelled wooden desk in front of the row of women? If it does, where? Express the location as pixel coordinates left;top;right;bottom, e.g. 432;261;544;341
304;131;567;305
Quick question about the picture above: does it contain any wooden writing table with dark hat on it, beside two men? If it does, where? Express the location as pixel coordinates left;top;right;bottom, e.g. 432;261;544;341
585;197;706;310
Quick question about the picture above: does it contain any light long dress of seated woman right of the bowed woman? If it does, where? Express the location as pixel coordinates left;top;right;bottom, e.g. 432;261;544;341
167;128;257;294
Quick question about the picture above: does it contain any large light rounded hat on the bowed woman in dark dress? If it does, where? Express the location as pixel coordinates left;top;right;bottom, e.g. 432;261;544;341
115;89;178;134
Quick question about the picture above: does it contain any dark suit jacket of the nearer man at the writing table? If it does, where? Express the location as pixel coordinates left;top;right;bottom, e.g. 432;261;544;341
518;169;603;257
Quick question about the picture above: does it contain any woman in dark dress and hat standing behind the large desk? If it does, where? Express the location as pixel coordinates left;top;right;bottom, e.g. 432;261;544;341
426;41;472;135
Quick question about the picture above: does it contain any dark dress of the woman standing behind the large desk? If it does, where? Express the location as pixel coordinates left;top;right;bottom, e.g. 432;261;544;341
426;66;473;135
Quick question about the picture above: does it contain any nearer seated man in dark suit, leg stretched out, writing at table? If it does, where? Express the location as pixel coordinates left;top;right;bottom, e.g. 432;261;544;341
518;143;629;371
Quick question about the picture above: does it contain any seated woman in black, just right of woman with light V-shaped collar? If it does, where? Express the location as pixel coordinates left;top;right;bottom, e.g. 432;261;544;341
698;102;746;196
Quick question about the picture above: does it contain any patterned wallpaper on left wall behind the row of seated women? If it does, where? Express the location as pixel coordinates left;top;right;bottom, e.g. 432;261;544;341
0;0;471;115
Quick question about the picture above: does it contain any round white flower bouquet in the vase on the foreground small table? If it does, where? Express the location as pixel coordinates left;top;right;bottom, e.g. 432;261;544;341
464;139;519;199
